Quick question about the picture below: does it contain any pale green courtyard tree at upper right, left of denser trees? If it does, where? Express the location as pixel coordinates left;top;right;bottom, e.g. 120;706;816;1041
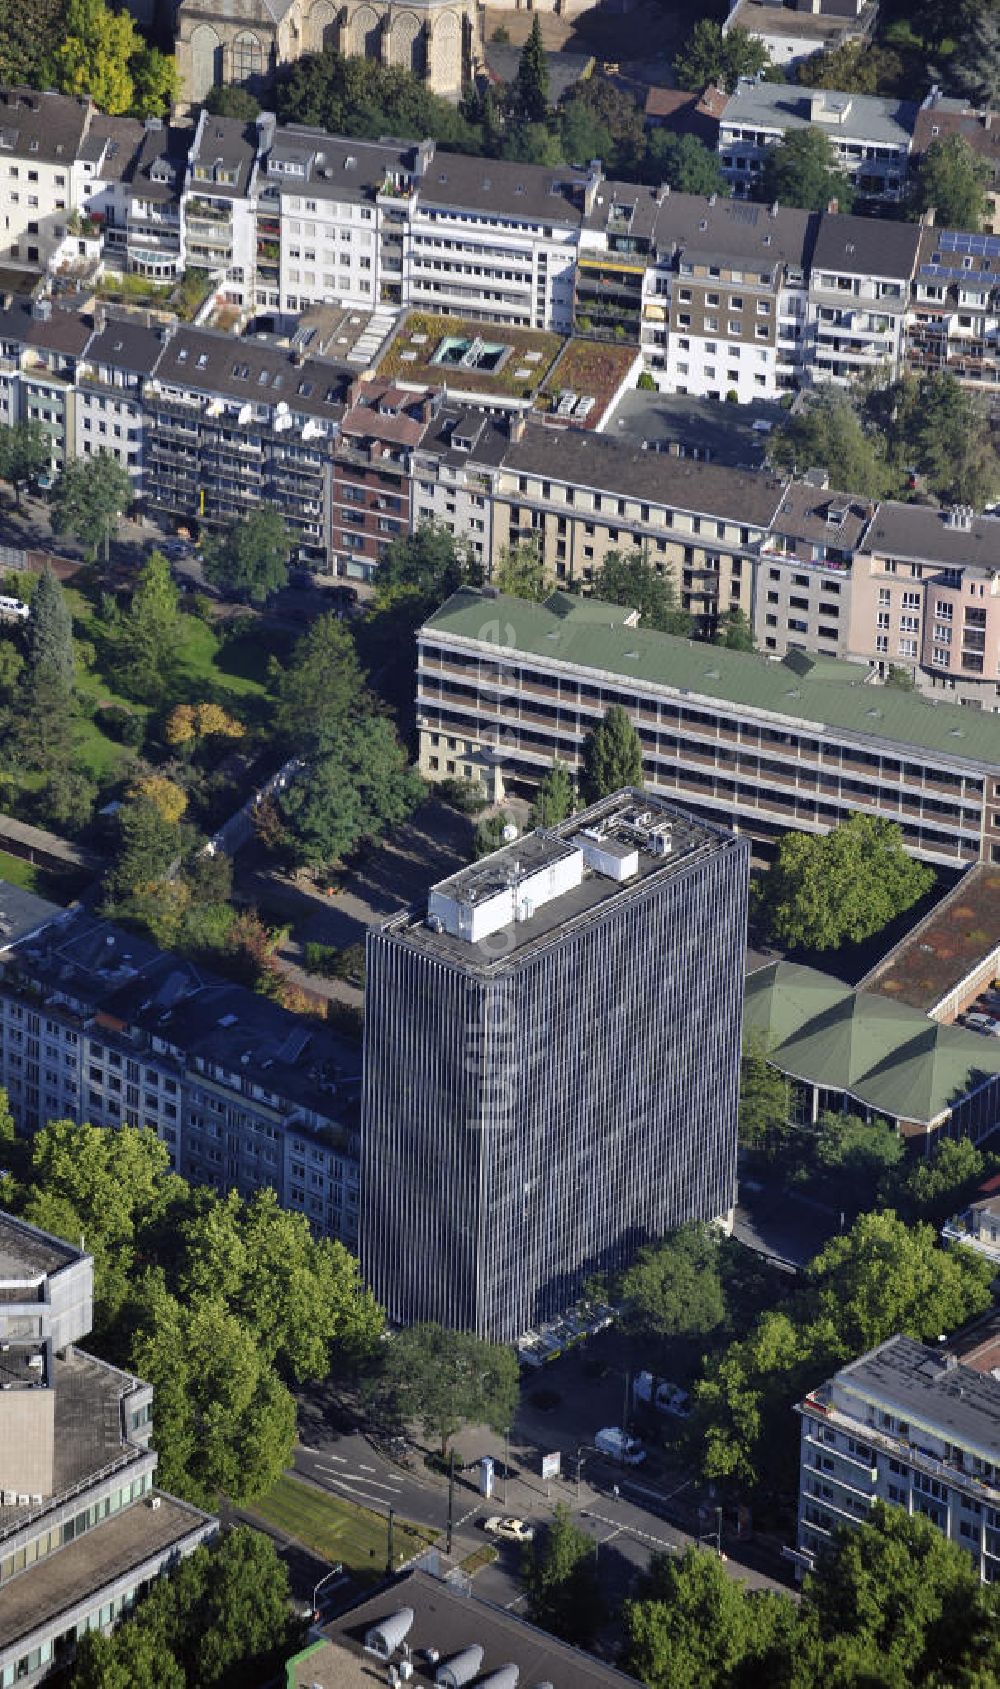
767;387;894;498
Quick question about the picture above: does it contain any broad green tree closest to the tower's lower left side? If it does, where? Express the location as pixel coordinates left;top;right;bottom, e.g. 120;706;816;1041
179;1189;382;1383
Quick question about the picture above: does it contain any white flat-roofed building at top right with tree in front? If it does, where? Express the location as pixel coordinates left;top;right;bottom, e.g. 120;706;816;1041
718;79;917;206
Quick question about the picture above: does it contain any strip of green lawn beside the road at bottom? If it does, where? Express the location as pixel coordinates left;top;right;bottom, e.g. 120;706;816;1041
248;1474;434;1578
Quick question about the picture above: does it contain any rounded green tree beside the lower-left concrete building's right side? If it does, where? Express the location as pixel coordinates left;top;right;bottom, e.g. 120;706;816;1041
130;1274;296;1507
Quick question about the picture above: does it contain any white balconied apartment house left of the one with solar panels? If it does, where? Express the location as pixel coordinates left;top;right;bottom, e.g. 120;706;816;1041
804;216;921;383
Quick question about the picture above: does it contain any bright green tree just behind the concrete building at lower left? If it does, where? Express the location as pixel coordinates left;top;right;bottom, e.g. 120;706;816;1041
24;1120;179;1331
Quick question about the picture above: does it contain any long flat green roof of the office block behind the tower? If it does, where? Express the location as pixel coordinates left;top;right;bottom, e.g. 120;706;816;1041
427;588;1000;767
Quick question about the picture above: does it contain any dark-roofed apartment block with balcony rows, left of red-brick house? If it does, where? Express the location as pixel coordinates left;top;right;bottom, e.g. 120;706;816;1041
144;328;346;569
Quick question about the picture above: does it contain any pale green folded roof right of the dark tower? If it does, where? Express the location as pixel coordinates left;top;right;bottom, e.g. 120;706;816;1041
743;963;1000;1125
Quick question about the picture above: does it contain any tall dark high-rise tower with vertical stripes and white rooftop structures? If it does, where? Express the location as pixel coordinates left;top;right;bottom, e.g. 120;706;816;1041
361;790;748;1339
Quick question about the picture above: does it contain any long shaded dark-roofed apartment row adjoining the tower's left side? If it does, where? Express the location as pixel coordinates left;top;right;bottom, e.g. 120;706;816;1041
0;885;360;1250
